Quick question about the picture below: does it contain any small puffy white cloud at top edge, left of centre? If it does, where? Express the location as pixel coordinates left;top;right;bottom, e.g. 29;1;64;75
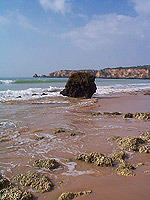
39;0;71;14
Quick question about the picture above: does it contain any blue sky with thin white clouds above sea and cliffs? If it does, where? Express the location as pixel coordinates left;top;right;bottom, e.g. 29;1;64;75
0;0;150;77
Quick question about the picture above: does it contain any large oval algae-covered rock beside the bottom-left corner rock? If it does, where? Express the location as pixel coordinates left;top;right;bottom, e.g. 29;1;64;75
14;172;53;192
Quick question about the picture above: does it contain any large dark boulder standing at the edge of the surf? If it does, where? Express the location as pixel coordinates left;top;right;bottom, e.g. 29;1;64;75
60;72;96;99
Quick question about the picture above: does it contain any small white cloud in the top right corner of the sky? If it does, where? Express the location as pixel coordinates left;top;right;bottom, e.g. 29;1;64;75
130;0;150;15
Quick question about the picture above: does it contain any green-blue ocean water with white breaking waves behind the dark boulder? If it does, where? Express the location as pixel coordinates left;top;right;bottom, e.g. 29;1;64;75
0;78;150;102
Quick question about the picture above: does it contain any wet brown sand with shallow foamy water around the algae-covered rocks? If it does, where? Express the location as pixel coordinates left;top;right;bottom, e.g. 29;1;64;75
0;92;150;200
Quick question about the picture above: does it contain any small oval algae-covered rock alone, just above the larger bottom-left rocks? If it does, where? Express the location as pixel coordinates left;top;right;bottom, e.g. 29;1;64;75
33;159;59;169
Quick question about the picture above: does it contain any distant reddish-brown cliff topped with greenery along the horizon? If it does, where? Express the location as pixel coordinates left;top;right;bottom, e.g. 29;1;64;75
34;65;150;79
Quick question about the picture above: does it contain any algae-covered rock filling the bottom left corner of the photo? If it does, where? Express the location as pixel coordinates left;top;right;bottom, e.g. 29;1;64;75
0;176;33;200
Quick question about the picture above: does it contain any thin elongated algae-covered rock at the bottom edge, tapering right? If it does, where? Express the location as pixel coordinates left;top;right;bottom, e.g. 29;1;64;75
58;190;92;200
